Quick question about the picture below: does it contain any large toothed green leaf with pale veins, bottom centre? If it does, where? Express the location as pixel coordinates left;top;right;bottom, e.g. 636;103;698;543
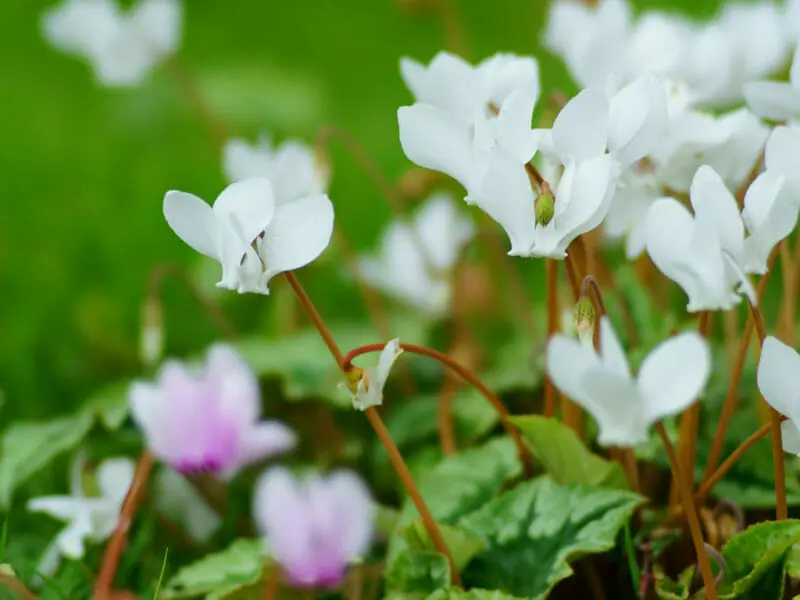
459;476;644;598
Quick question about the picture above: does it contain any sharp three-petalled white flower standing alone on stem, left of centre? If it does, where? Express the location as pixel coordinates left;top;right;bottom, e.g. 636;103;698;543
164;177;333;294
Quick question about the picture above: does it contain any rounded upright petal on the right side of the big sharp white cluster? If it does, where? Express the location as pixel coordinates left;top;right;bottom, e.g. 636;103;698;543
608;75;667;166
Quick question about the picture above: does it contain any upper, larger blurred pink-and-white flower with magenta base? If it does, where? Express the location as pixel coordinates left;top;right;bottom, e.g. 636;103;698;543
129;345;296;474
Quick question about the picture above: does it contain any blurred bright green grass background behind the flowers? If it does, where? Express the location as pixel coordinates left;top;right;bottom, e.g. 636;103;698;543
0;0;718;422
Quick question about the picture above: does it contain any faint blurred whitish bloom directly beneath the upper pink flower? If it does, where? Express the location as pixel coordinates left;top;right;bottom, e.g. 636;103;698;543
153;465;222;543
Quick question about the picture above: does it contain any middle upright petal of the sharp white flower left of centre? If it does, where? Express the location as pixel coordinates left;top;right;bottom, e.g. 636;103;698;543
214;177;275;245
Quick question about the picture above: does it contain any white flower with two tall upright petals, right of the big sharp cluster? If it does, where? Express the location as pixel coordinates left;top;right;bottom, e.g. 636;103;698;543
646;166;756;312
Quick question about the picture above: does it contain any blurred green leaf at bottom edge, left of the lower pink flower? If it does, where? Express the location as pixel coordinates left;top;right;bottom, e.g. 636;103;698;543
161;539;265;600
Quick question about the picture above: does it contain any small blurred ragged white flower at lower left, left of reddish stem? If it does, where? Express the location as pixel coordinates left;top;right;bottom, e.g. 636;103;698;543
27;456;135;576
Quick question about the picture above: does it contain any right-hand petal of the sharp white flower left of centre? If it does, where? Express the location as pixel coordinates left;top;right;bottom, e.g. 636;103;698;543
261;194;333;279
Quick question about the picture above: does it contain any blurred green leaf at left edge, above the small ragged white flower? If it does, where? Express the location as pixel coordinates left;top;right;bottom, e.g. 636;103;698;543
0;412;94;508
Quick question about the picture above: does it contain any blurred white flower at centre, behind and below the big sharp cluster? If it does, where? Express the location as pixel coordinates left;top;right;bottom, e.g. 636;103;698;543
359;194;475;317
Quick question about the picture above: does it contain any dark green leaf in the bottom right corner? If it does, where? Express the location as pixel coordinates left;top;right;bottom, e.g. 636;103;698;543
718;519;800;600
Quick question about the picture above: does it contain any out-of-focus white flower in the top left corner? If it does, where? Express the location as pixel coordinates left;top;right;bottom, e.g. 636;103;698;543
43;0;182;87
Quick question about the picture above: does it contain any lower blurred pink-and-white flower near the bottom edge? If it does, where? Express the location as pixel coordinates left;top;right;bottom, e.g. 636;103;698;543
253;467;375;588
